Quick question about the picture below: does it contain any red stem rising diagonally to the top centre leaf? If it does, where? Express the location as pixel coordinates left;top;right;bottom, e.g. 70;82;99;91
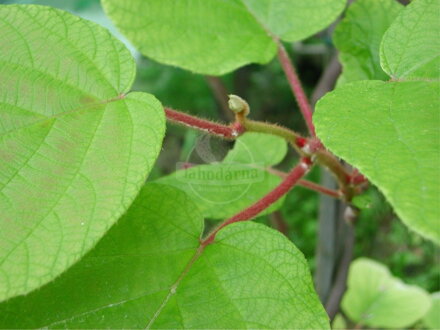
278;41;316;136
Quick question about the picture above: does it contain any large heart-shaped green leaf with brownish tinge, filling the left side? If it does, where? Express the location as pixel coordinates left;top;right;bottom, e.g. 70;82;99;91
0;5;165;301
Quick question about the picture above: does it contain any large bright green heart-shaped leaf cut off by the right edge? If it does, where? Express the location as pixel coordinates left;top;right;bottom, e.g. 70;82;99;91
314;0;440;243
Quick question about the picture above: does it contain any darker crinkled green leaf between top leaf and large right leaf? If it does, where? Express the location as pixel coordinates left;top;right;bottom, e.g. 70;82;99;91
333;0;403;83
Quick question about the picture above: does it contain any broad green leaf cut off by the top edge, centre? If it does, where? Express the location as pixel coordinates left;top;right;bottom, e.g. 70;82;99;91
102;0;345;75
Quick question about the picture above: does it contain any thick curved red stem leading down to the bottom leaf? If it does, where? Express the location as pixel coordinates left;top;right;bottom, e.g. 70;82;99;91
202;157;313;245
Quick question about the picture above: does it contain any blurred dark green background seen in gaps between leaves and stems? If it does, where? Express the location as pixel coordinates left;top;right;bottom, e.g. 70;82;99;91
0;0;440;292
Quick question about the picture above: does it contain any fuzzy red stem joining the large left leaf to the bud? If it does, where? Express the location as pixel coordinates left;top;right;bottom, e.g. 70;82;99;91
165;108;241;140
